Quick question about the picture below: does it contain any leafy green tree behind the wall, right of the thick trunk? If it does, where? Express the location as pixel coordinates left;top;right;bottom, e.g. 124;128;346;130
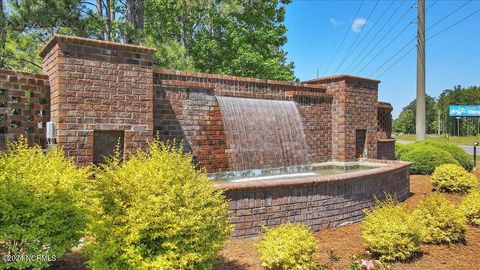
145;0;295;80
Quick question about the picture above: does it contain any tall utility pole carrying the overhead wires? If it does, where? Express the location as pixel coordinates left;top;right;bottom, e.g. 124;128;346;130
415;0;426;141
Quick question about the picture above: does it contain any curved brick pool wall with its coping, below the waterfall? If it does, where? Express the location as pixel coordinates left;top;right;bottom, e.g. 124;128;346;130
217;160;410;238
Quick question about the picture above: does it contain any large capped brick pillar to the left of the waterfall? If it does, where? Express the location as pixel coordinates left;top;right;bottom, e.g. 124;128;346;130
40;35;154;165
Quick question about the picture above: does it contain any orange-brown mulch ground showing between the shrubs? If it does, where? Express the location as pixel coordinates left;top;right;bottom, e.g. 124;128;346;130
50;175;480;270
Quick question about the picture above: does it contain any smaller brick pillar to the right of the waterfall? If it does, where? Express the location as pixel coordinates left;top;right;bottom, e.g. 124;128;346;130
307;75;380;161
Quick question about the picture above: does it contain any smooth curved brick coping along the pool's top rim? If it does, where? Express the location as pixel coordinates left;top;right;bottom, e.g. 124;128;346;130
215;159;411;191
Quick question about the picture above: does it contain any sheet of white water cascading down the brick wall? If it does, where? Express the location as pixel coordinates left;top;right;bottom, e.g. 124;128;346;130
217;96;308;171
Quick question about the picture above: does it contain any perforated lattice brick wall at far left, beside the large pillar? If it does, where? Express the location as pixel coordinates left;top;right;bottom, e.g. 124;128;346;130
0;69;50;150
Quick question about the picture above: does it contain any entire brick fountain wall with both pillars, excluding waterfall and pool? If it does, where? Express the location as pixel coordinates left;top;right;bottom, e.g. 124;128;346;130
0;36;394;172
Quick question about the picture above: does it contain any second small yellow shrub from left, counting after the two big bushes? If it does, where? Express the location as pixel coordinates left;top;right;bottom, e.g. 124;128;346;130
362;197;420;261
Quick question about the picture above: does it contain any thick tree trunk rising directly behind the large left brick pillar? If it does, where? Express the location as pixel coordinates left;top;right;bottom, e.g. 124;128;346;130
125;0;145;43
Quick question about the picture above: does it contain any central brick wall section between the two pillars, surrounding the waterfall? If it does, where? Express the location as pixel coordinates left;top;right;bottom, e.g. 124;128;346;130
154;70;332;172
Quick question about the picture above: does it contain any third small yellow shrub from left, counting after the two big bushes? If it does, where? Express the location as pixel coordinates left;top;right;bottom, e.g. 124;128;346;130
414;193;467;243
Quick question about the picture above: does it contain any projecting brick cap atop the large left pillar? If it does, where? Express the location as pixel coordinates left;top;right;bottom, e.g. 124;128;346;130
40;35;156;57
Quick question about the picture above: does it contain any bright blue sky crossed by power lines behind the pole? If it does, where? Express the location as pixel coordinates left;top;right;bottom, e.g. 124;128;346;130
285;0;480;118
